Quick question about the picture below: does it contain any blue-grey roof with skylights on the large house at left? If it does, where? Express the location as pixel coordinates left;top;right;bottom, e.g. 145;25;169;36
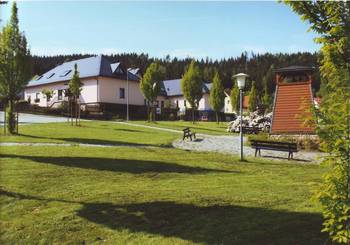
27;55;139;87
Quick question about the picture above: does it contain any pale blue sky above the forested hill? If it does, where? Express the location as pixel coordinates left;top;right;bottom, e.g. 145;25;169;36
1;1;319;59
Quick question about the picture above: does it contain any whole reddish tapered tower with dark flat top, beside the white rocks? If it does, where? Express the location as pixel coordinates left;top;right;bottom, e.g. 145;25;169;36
270;66;314;134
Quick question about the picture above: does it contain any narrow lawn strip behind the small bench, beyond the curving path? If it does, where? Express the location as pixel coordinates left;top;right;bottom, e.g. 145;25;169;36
131;121;232;135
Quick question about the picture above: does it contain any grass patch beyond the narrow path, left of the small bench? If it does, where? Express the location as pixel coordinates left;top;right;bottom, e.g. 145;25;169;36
0;121;181;146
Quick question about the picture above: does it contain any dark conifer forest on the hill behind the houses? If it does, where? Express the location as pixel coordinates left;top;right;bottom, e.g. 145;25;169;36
32;52;320;92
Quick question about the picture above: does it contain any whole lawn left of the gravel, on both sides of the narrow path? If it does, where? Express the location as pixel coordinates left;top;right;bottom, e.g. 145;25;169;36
0;122;325;244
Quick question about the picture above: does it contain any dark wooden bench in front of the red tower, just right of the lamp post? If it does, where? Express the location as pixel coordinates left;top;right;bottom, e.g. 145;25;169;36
251;140;298;160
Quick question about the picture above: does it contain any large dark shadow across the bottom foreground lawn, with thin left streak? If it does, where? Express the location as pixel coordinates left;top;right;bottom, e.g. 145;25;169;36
0;190;326;245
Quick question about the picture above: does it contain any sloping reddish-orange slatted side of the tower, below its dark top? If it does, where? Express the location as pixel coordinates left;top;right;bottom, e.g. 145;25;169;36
271;83;314;134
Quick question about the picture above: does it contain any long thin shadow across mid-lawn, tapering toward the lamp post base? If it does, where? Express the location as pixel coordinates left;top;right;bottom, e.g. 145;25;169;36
0;154;235;174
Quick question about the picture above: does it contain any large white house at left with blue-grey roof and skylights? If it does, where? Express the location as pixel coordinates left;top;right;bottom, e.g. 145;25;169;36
24;55;145;111
